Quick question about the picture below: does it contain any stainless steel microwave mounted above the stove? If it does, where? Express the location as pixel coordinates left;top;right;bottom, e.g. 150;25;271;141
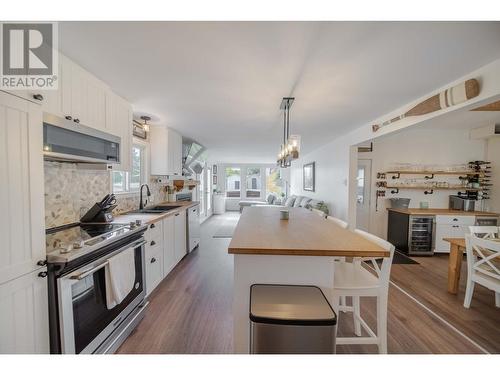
43;113;121;164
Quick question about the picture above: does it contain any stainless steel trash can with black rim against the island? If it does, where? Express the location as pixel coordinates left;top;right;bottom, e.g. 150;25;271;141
250;284;337;354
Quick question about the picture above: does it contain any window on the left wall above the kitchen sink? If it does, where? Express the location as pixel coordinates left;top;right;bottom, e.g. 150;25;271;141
112;144;146;193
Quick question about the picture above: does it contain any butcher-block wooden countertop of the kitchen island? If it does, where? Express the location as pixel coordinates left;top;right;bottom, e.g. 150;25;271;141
228;206;389;257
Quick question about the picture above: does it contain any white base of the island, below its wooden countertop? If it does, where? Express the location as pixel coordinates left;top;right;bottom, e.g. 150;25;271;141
233;254;334;354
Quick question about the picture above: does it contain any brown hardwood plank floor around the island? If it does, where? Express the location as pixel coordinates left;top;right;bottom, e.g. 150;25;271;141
118;213;500;354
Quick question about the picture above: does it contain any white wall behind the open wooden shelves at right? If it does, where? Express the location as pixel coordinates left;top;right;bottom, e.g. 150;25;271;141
366;128;486;238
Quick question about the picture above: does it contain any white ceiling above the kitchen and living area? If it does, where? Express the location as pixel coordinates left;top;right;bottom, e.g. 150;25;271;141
59;22;500;162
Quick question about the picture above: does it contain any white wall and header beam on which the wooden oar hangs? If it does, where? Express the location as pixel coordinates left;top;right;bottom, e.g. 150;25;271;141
291;60;500;227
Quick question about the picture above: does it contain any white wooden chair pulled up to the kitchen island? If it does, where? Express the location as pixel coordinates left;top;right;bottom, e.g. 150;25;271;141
332;229;394;354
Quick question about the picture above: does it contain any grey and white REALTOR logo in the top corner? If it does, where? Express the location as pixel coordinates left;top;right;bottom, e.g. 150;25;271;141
0;22;58;90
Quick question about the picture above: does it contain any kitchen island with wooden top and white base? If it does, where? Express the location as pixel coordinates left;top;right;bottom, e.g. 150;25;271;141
228;207;389;353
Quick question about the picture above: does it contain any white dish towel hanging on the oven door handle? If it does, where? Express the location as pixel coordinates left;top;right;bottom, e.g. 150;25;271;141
105;248;135;310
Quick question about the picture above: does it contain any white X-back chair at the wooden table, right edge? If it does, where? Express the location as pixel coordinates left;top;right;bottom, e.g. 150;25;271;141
464;234;500;309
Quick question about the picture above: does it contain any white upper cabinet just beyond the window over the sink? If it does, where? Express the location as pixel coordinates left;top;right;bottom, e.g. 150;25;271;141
150;126;186;176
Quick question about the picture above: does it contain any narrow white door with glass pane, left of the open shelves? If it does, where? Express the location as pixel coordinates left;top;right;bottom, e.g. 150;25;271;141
356;159;372;231
